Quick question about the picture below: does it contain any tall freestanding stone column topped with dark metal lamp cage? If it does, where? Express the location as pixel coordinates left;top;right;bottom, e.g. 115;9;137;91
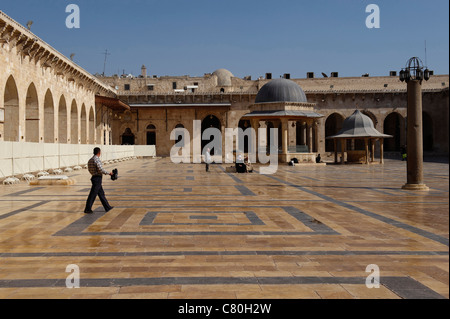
400;57;431;191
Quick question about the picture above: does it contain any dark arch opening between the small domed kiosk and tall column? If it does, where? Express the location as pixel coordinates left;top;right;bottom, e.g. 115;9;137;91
383;112;406;152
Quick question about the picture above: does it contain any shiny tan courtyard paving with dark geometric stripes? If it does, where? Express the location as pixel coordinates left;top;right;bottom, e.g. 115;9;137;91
0;159;449;299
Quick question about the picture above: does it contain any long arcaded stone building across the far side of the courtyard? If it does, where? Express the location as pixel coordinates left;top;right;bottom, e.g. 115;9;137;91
100;66;449;157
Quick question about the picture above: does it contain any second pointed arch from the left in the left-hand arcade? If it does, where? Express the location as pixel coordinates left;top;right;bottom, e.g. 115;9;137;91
25;83;40;143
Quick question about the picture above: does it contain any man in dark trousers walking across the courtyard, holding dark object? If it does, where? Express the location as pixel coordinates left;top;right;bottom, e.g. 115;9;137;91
84;147;114;214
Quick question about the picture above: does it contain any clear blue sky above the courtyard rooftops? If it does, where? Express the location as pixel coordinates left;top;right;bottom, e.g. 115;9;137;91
0;0;449;78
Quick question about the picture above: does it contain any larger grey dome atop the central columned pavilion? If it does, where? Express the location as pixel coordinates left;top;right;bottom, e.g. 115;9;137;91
255;79;308;104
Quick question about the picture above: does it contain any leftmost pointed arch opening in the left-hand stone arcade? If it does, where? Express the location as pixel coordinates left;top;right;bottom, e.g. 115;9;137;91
3;75;20;142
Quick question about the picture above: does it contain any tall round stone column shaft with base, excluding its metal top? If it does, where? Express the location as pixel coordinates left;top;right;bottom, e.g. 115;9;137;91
403;80;429;190
